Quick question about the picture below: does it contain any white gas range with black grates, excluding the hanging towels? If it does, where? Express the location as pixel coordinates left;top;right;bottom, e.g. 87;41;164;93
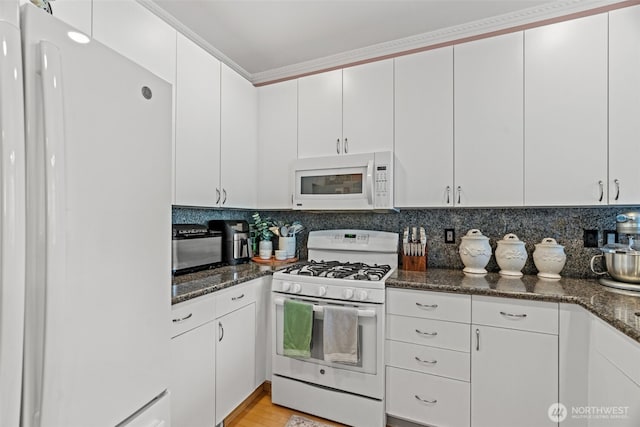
272;230;399;427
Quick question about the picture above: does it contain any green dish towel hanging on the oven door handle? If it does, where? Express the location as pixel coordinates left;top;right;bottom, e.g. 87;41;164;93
283;300;313;358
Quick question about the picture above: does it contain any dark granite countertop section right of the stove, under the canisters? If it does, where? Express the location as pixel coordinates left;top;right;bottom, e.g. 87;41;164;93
386;269;640;342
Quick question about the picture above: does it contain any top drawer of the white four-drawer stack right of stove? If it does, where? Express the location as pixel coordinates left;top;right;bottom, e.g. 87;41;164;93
387;289;471;323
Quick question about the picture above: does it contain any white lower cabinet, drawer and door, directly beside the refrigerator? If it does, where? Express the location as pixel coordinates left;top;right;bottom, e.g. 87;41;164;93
169;295;216;427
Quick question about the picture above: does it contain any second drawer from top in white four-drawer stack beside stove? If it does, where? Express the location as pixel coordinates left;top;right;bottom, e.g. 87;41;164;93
386;314;471;352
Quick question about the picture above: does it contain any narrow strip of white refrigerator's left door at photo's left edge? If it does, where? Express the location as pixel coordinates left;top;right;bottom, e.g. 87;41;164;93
0;7;25;426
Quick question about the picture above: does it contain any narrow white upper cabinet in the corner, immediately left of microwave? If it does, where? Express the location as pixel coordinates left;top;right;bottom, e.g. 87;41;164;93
257;80;298;209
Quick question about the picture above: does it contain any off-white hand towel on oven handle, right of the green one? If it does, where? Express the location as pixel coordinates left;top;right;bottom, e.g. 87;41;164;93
322;305;358;364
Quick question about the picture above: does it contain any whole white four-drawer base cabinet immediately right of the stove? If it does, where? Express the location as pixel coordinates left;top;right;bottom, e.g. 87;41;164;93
386;289;471;427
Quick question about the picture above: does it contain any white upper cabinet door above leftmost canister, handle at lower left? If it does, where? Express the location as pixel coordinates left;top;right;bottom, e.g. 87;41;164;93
454;32;524;206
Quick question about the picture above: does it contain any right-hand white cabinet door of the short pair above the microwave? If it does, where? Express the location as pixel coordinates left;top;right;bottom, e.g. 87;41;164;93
342;59;393;154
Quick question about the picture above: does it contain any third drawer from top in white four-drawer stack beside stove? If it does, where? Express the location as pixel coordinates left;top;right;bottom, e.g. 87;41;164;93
386;340;471;382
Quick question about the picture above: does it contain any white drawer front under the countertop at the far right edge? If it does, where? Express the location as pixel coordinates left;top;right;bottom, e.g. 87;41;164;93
592;318;640;385
